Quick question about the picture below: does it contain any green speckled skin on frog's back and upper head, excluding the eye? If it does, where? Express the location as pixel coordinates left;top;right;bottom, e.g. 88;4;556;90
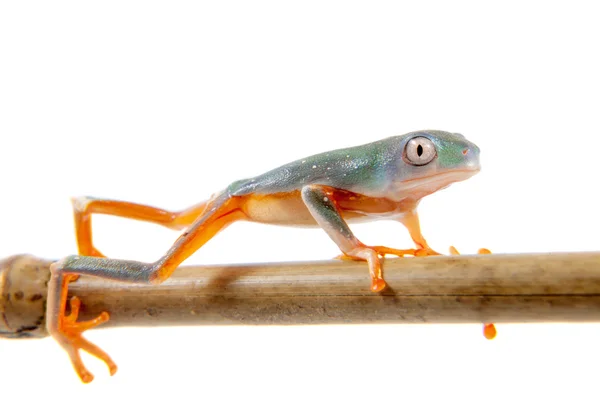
227;130;479;200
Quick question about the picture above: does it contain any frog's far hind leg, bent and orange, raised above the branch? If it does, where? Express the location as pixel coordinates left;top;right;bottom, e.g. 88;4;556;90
72;197;206;257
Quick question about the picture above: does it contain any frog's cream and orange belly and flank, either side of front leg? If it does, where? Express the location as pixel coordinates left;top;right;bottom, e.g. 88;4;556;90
242;191;403;227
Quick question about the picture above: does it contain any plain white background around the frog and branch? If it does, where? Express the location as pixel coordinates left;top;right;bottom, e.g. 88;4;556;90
0;1;600;399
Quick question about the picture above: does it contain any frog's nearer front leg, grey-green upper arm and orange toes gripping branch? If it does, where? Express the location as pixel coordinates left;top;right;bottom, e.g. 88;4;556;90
302;185;415;292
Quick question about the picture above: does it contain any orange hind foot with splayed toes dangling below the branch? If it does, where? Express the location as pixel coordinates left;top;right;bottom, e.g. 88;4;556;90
59;296;117;383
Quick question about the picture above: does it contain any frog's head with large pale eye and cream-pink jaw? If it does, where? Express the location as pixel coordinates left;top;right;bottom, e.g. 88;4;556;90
395;130;481;197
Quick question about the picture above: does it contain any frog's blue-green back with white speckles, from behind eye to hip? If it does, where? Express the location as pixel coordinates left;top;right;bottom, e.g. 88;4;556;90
227;137;399;196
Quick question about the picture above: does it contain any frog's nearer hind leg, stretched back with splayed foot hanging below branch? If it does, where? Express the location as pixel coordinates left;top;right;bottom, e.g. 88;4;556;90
46;194;245;383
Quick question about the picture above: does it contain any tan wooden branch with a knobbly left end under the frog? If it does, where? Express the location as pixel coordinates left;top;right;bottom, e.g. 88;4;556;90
0;252;600;338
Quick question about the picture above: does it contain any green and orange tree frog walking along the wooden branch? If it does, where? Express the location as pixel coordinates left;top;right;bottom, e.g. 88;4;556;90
47;130;480;382
